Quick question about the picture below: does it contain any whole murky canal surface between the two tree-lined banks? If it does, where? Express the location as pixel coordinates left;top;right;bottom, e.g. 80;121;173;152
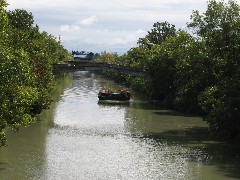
0;71;240;180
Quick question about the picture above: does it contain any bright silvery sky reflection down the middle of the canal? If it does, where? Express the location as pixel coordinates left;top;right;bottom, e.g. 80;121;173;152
42;73;212;180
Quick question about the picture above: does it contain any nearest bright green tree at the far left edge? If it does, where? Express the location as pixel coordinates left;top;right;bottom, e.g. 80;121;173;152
0;5;38;146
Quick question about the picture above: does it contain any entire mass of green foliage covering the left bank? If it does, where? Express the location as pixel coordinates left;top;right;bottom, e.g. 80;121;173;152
0;0;68;146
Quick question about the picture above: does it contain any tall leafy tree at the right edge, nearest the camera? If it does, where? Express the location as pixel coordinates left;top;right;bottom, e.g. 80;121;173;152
188;0;240;138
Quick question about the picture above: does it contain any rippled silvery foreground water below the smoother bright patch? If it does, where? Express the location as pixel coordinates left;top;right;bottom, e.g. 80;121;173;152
44;121;211;180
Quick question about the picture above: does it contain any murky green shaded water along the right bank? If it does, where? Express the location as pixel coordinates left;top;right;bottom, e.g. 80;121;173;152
125;98;240;179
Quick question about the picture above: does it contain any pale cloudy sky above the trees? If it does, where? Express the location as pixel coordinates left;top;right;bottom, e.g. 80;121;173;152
7;0;228;54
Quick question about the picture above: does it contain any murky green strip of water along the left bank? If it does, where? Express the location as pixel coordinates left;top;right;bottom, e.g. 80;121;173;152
0;75;72;180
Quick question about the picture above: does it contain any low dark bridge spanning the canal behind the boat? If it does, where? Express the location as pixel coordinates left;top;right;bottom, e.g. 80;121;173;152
53;61;148;79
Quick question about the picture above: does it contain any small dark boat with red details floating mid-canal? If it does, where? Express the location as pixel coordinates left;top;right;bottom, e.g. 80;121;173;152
98;90;131;102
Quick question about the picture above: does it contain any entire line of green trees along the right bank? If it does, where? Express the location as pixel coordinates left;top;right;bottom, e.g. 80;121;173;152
96;0;240;140
